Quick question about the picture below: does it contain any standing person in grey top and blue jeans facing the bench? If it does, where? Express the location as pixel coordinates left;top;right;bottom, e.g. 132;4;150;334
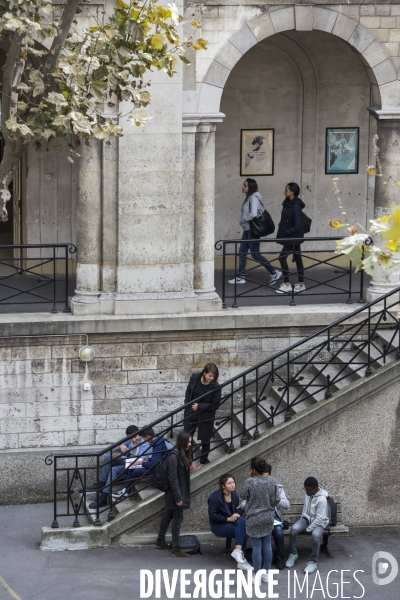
240;456;281;581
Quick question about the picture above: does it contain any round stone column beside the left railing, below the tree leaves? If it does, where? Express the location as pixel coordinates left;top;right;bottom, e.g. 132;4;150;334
71;139;102;315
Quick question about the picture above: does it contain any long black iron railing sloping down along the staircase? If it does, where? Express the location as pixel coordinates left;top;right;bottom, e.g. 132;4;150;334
46;287;400;527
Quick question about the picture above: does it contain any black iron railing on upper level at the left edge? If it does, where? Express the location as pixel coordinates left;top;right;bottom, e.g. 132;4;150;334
0;244;76;313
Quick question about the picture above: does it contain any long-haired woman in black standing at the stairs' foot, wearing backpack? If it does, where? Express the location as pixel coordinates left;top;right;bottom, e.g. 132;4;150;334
156;431;192;558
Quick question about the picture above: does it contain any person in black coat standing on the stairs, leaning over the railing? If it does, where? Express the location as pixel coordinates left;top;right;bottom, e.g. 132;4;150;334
184;363;221;469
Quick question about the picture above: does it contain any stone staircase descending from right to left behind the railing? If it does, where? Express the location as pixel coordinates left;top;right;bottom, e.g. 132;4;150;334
41;328;400;550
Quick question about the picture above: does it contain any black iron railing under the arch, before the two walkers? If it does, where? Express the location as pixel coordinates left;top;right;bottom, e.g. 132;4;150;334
215;236;372;308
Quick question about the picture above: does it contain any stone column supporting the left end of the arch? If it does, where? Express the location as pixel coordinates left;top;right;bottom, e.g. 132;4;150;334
194;122;221;310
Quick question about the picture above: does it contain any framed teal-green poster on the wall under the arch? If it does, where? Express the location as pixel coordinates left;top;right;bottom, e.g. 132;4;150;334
325;127;359;175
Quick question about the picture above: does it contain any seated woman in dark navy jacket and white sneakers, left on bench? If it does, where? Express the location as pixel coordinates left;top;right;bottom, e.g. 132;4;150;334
208;473;253;571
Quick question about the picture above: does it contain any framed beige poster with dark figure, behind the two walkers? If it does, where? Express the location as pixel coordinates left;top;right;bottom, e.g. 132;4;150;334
240;129;274;177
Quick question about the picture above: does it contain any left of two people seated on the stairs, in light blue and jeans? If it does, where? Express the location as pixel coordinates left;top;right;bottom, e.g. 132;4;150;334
86;425;149;509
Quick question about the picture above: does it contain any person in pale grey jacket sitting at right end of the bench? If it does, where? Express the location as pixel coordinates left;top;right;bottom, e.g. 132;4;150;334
286;477;329;573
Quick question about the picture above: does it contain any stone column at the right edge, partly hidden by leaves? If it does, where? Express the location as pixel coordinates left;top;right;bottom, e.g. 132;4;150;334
366;111;400;302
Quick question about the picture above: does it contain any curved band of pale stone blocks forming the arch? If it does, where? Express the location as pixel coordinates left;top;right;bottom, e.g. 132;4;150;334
198;6;400;114
